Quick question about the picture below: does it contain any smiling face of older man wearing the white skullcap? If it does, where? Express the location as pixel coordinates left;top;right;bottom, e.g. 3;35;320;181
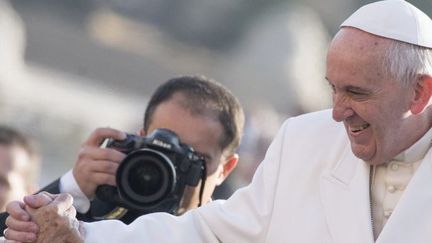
327;28;426;164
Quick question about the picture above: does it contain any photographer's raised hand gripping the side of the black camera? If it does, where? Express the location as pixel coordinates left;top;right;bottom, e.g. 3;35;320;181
73;128;126;198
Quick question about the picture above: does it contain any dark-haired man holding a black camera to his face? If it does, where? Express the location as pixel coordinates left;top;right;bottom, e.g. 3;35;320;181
1;76;244;239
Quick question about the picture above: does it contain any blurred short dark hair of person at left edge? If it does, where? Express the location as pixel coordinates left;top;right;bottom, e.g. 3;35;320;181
0;125;39;185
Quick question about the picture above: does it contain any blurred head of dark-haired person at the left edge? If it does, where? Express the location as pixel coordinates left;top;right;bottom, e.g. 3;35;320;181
0;125;40;211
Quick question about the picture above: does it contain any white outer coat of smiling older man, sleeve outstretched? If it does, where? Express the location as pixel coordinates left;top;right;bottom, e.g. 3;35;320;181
84;110;432;243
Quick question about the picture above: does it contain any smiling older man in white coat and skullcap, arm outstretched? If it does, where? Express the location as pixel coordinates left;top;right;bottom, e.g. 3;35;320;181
6;0;432;243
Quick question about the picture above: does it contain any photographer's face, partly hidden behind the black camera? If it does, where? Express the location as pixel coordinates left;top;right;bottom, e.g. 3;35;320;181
141;94;238;213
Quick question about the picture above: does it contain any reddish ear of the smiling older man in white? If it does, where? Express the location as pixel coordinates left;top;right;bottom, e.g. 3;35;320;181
410;75;432;115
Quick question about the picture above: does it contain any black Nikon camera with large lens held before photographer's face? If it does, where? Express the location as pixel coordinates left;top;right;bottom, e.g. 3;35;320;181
96;129;206;214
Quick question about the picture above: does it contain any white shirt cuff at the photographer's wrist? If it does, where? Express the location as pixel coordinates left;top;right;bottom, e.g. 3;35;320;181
59;170;90;214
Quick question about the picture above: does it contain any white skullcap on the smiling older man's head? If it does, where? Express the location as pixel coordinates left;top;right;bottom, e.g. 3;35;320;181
340;0;432;48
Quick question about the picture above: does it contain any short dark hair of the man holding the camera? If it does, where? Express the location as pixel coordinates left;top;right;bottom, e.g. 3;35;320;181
144;75;245;153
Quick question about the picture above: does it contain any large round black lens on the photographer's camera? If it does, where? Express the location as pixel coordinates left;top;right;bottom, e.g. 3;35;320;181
116;149;176;209
